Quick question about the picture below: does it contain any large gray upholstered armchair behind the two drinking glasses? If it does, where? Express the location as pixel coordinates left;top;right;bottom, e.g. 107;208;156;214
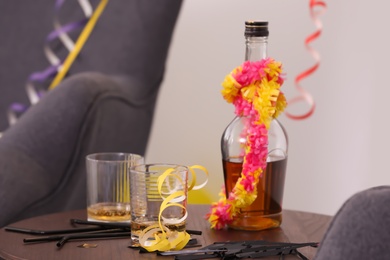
0;0;181;227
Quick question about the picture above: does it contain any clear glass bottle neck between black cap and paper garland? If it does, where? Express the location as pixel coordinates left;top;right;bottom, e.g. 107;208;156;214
245;36;268;61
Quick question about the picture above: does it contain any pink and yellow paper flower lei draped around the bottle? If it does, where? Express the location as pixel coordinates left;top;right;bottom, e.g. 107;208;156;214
207;58;287;229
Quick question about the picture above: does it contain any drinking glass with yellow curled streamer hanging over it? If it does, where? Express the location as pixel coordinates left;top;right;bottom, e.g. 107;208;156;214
130;164;189;245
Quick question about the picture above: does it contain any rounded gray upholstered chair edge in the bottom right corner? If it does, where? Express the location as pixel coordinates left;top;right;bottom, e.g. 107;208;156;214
315;186;390;260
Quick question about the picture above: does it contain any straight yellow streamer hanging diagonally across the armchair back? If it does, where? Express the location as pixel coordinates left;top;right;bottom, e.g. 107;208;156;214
49;0;108;90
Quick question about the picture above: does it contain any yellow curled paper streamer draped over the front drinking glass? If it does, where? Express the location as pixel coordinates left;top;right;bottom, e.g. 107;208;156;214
139;165;208;252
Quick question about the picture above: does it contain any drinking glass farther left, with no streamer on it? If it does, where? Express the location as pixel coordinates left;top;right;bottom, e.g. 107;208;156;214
86;153;144;222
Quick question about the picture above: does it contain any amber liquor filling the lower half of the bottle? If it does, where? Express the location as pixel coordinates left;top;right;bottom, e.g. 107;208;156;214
222;158;287;230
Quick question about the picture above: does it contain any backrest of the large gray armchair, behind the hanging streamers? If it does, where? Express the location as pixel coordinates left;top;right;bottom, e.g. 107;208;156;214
0;0;181;132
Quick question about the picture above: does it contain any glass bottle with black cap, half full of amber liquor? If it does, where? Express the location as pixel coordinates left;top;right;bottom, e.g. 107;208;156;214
221;21;288;230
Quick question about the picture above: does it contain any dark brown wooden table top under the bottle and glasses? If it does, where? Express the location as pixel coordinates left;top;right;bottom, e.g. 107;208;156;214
0;205;331;260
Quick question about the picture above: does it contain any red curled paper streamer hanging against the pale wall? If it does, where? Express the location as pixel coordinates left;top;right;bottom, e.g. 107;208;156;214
285;0;326;120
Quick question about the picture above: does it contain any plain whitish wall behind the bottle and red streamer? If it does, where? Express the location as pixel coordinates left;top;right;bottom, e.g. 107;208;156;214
146;0;390;214
